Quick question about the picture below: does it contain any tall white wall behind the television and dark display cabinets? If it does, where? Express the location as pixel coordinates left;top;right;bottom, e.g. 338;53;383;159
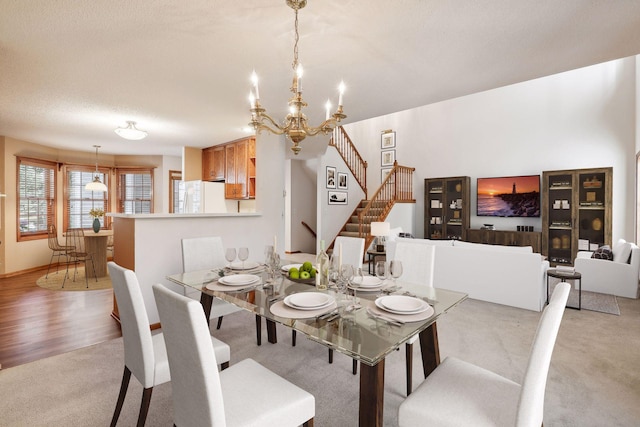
342;57;638;241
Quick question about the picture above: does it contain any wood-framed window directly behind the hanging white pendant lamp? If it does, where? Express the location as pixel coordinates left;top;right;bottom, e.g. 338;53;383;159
64;165;110;230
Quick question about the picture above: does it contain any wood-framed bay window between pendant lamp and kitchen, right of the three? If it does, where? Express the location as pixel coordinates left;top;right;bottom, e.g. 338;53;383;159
118;169;153;214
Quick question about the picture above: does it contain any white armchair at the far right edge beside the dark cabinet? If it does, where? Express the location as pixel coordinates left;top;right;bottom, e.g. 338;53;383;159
574;239;640;298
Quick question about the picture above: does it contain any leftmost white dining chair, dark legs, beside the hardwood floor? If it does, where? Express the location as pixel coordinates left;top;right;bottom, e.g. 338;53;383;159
107;262;231;427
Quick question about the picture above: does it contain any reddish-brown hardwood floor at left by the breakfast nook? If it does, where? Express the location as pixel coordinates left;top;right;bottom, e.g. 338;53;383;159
0;269;122;369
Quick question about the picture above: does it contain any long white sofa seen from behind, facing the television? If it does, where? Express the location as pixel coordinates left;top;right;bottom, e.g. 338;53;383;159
387;238;549;311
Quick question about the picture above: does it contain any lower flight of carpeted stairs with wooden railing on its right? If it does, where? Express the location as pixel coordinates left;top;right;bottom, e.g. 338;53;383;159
358;161;416;248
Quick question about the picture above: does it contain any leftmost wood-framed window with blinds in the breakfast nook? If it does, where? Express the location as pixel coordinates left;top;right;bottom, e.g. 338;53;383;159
17;157;57;241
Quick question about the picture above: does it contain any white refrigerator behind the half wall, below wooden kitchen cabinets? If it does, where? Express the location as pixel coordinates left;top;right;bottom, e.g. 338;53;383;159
179;181;238;213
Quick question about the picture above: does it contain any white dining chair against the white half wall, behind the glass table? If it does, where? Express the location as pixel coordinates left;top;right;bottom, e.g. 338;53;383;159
182;236;242;329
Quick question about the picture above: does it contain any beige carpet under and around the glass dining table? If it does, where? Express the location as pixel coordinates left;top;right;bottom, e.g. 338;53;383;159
0;298;640;427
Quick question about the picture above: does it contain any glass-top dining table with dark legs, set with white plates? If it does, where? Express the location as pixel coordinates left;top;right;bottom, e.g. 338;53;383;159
167;269;467;427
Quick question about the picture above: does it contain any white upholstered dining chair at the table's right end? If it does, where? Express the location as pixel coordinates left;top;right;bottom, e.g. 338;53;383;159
398;282;571;427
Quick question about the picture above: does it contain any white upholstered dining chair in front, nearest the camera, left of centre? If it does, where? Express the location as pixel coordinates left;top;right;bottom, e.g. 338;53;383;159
153;284;315;427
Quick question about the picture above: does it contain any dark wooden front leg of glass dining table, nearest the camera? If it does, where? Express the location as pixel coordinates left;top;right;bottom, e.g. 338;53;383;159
358;359;384;427
